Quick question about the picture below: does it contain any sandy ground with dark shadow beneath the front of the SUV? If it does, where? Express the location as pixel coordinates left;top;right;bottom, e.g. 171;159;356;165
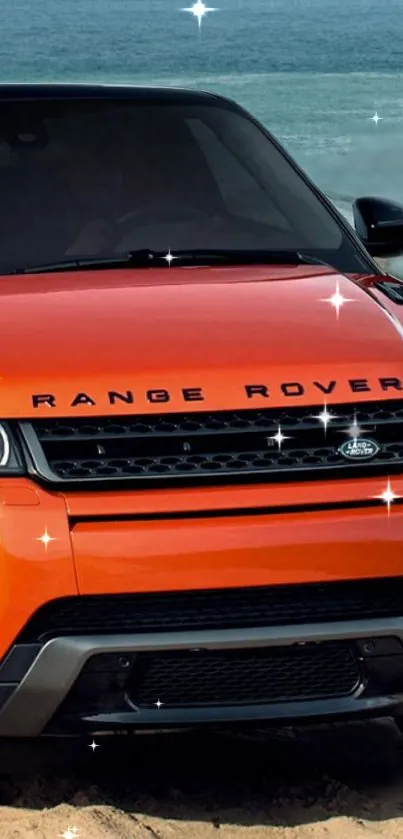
0;720;403;839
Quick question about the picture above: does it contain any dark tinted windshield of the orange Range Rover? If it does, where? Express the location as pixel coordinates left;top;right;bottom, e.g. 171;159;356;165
0;94;365;272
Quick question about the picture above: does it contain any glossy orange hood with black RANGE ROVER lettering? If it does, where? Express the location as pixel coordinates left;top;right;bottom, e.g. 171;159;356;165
0;266;403;418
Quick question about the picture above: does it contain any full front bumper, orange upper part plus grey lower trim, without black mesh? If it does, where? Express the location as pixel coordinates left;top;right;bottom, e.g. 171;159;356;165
0;478;403;736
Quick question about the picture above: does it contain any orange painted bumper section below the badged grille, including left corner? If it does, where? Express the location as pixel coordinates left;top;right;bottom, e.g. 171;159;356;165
0;470;403;657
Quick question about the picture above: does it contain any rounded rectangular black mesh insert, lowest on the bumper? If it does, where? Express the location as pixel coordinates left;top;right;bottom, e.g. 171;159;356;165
128;644;359;707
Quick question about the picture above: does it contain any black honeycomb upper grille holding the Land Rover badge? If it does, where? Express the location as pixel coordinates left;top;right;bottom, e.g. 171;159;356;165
22;400;403;484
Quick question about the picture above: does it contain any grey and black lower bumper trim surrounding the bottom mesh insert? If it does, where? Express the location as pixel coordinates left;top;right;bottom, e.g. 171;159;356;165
0;618;403;737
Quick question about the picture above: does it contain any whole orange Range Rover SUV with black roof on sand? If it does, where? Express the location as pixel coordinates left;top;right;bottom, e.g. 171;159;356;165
0;85;403;737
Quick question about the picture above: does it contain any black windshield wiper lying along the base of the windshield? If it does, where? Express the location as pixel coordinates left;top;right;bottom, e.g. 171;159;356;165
11;249;333;274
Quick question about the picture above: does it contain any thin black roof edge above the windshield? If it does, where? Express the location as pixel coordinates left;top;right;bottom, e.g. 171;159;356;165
0;82;236;107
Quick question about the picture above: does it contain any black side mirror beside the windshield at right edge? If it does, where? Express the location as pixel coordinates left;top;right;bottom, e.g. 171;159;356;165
353;198;403;256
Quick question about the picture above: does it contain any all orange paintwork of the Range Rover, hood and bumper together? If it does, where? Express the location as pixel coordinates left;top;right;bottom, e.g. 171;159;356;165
0;266;403;658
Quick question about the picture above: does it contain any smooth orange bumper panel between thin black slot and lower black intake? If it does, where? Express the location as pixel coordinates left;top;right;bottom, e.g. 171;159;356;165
72;507;403;594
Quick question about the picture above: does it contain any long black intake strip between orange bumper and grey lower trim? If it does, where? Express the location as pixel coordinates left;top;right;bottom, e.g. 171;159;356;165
16;577;403;643
